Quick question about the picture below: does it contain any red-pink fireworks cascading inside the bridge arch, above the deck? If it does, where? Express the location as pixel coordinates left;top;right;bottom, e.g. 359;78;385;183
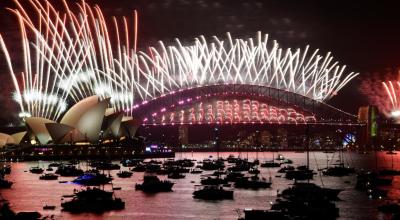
144;99;316;125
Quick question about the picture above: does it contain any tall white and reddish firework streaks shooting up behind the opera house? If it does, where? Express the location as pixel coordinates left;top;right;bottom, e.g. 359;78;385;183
0;0;138;120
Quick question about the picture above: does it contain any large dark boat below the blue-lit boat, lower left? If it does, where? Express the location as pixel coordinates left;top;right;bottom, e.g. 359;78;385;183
61;187;125;213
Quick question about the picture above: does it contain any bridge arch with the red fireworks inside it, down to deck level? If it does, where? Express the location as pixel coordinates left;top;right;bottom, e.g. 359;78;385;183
132;84;359;126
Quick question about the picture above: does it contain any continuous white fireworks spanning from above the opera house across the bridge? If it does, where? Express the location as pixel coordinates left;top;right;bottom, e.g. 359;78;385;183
0;0;357;120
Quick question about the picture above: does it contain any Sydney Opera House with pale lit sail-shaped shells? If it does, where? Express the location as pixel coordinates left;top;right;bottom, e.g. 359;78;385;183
0;96;138;146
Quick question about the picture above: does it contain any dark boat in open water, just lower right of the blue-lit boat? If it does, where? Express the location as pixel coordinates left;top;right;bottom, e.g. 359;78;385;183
135;175;174;193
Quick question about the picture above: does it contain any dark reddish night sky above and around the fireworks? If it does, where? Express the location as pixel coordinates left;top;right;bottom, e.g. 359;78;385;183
0;0;400;123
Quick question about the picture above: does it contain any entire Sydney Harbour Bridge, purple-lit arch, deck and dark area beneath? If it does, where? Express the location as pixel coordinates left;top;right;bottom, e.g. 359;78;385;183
132;84;367;150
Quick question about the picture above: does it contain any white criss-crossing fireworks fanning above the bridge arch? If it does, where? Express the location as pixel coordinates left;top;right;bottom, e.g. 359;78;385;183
129;32;358;107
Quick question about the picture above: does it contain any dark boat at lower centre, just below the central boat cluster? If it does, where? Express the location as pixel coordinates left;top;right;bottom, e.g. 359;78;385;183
193;186;233;200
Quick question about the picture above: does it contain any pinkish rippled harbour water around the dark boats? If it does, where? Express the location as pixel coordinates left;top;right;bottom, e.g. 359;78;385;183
1;152;400;220
